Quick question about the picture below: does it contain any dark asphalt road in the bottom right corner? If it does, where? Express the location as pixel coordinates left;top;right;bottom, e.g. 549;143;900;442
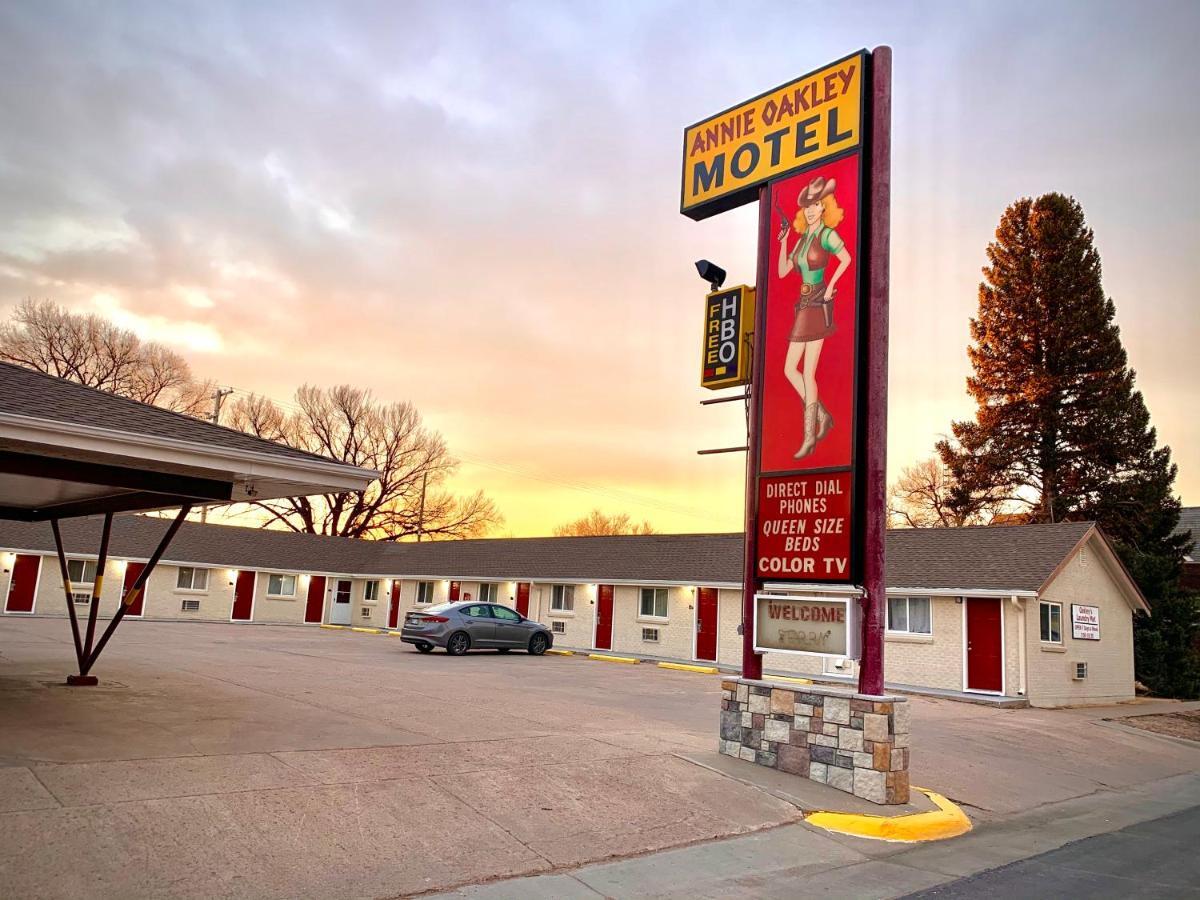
908;806;1200;900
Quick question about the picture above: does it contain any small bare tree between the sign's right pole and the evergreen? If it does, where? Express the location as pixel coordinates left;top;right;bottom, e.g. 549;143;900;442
888;458;1009;528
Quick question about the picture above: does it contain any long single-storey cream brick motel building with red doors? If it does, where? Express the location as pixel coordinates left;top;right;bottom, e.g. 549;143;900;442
0;516;1148;707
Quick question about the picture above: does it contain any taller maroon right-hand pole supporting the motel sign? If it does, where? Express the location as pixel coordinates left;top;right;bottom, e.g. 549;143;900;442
858;47;892;696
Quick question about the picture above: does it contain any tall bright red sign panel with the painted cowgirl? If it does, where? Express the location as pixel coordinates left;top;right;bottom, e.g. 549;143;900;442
758;152;860;474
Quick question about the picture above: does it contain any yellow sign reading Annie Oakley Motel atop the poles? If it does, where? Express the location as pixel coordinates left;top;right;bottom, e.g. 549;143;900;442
679;50;866;221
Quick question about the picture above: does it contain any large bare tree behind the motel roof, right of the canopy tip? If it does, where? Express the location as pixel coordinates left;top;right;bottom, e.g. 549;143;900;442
230;384;503;540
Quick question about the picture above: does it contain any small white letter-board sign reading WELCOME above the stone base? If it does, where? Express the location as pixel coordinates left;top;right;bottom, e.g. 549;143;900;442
754;594;851;656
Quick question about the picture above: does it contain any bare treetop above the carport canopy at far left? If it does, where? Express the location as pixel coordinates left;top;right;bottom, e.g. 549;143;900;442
0;300;214;416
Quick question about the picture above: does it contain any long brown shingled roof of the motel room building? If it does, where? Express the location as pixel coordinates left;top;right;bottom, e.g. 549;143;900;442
0;516;1094;592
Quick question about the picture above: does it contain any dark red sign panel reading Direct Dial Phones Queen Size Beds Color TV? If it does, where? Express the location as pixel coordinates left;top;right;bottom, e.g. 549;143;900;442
755;472;852;582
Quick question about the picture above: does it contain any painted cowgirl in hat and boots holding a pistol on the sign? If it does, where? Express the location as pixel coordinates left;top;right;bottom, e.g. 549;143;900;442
779;175;850;460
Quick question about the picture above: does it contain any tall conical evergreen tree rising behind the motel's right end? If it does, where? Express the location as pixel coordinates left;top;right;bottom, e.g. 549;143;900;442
937;193;1186;601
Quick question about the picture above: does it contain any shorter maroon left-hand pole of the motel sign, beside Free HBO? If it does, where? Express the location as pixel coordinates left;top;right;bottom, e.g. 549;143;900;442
742;185;770;678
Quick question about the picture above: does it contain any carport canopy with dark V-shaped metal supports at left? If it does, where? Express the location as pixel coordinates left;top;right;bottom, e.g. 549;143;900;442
0;362;378;684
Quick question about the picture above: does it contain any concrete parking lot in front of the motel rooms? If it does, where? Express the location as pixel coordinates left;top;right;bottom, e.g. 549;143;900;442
0;618;1200;898
